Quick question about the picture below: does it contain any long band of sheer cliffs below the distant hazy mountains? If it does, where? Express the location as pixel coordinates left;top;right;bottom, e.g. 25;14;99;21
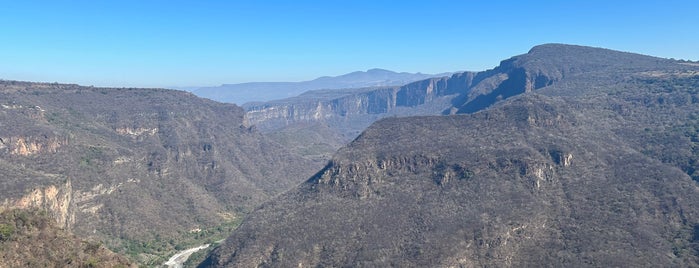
245;72;474;130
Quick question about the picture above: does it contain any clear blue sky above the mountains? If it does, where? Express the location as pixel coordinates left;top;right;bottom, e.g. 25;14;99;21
0;0;699;87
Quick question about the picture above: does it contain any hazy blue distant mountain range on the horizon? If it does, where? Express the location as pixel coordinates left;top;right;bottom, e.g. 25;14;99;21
189;69;450;105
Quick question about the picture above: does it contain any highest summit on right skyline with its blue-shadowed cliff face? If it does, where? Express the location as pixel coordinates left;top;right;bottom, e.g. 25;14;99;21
454;44;681;113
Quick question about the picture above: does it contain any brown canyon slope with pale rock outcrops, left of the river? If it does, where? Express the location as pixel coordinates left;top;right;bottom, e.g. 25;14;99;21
0;81;320;264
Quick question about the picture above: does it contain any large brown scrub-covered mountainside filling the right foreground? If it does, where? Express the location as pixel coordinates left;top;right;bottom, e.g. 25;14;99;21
203;45;699;267
